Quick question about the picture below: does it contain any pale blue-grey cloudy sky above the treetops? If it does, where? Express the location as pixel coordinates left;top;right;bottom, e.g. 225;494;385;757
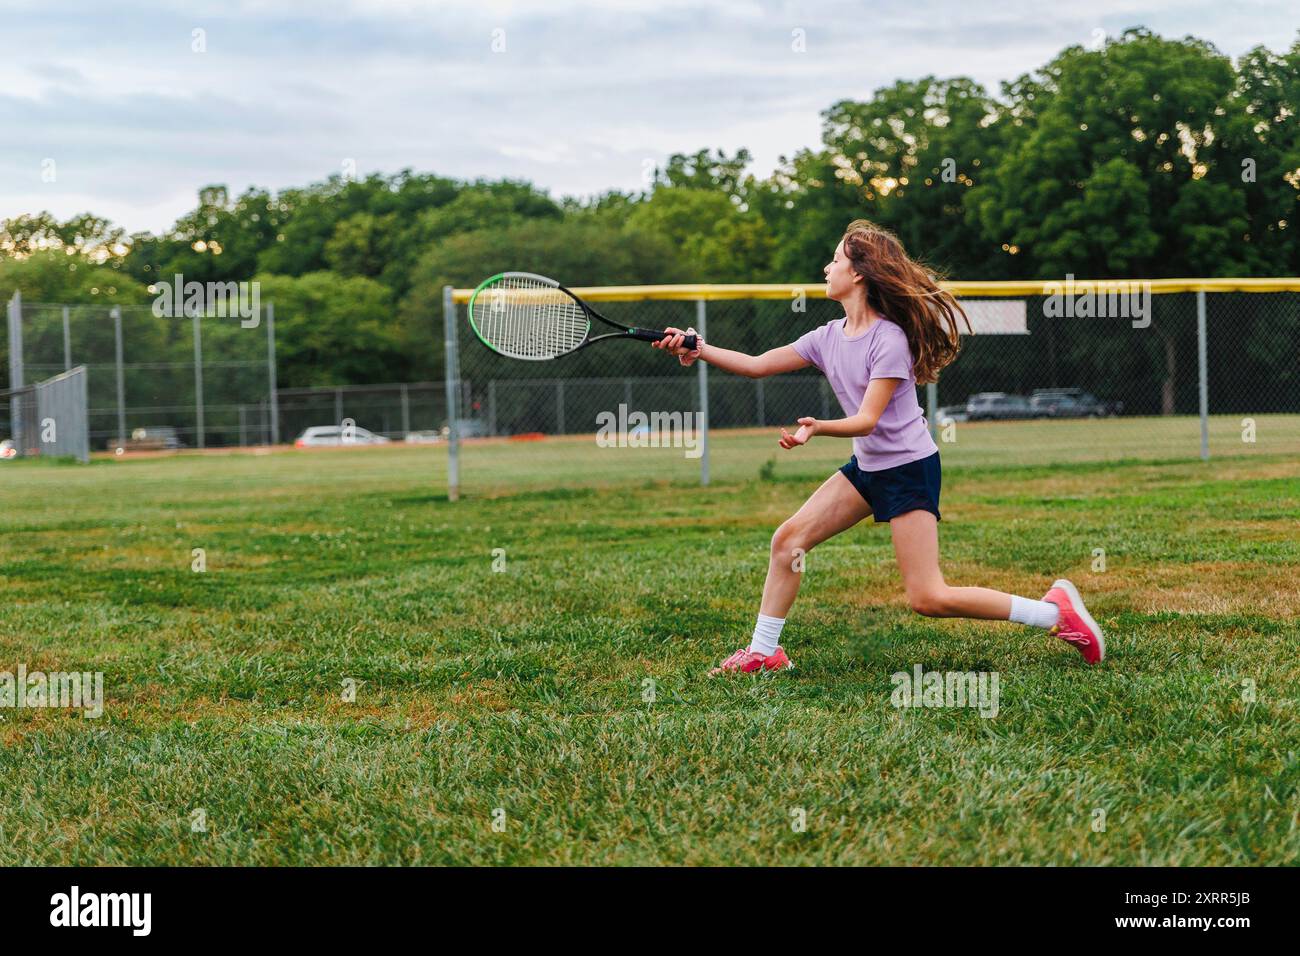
0;0;1300;232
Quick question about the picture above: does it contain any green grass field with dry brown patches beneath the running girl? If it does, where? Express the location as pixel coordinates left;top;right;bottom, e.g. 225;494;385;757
0;418;1300;865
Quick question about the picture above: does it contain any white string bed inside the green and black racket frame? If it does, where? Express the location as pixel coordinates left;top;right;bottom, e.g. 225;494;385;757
475;276;590;359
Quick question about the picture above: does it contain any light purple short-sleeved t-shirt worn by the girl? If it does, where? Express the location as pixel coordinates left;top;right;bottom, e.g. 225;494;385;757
794;319;939;471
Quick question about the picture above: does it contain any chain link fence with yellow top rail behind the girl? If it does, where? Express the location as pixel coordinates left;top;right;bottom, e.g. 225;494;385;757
445;281;1300;494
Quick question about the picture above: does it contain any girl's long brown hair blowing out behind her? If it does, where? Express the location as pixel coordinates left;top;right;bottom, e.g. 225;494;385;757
844;219;971;385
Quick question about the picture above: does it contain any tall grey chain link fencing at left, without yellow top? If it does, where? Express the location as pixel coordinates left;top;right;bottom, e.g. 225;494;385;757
0;295;452;451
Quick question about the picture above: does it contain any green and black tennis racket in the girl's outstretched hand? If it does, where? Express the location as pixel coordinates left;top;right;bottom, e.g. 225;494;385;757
469;272;696;362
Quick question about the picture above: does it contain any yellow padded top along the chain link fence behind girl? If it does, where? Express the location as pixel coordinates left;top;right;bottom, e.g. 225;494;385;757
452;278;1300;303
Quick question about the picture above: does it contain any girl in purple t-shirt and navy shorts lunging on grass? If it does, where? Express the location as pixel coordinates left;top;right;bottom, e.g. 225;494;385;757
654;220;1106;676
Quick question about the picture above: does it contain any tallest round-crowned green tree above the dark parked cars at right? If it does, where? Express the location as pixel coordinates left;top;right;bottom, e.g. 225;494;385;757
970;30;1251;414
